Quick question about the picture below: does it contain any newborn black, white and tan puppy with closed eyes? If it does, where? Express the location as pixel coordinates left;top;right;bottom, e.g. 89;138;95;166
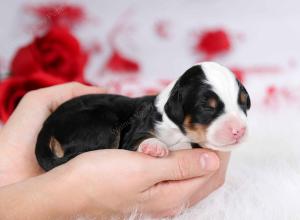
35;62;250;170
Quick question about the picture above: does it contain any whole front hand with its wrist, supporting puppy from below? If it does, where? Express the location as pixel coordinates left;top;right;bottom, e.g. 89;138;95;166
0;149;229;220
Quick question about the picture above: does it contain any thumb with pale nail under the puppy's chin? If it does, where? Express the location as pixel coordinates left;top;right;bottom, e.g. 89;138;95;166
149;149;220;182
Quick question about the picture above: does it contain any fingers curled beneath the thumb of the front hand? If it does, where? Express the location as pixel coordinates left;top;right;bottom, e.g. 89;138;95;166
144;149;230;217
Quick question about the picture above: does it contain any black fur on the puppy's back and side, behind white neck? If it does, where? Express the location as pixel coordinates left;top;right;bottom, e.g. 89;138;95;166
35;94;161;170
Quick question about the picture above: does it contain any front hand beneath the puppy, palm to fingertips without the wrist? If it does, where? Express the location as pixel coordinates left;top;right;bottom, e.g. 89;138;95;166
66;149;229;219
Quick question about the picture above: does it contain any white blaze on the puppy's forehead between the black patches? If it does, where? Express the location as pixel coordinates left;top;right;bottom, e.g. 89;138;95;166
199;62;241;113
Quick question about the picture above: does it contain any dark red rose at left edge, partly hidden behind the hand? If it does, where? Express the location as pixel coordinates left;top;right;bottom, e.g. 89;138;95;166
0;72;66;122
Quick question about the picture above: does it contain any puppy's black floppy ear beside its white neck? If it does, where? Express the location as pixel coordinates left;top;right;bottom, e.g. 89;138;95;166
164;85;184;127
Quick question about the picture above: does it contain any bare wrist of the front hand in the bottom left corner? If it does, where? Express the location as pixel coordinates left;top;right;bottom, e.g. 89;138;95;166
0;162;85;219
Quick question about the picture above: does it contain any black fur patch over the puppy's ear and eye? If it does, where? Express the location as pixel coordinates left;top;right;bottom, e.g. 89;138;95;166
165;66;224;132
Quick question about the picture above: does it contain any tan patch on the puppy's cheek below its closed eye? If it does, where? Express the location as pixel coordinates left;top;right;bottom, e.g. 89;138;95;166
183;115;208;145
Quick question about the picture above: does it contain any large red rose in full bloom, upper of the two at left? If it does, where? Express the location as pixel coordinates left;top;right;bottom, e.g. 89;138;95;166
11;26;87;82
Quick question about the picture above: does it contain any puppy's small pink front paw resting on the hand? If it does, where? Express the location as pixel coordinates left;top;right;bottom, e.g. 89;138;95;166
137;138;169;157
